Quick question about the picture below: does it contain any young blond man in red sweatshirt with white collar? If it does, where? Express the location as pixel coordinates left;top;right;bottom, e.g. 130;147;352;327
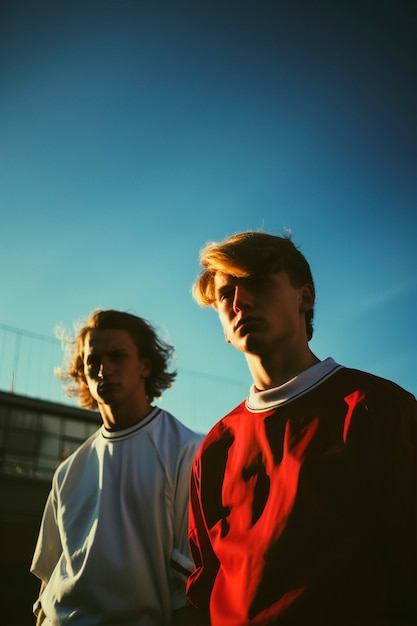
188;232;417;626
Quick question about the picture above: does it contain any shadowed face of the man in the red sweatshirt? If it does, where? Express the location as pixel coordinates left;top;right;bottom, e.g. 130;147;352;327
214;271;314;355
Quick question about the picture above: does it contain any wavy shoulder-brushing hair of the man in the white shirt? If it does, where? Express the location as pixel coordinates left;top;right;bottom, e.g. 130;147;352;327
55;309;177;409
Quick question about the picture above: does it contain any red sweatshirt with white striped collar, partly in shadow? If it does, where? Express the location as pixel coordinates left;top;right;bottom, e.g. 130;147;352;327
188;359;417;626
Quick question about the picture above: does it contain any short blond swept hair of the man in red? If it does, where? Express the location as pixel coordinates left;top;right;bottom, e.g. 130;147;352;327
193;231;314;340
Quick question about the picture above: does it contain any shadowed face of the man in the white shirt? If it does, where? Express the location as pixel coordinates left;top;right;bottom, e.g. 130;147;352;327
84;328;150;409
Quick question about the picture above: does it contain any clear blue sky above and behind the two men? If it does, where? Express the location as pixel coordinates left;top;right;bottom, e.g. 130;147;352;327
0;0;417;431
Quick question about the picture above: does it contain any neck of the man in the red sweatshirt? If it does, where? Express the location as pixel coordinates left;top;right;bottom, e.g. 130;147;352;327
246;347;320;391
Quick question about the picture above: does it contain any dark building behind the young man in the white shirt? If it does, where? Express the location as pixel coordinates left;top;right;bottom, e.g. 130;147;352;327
0;391;101;626
